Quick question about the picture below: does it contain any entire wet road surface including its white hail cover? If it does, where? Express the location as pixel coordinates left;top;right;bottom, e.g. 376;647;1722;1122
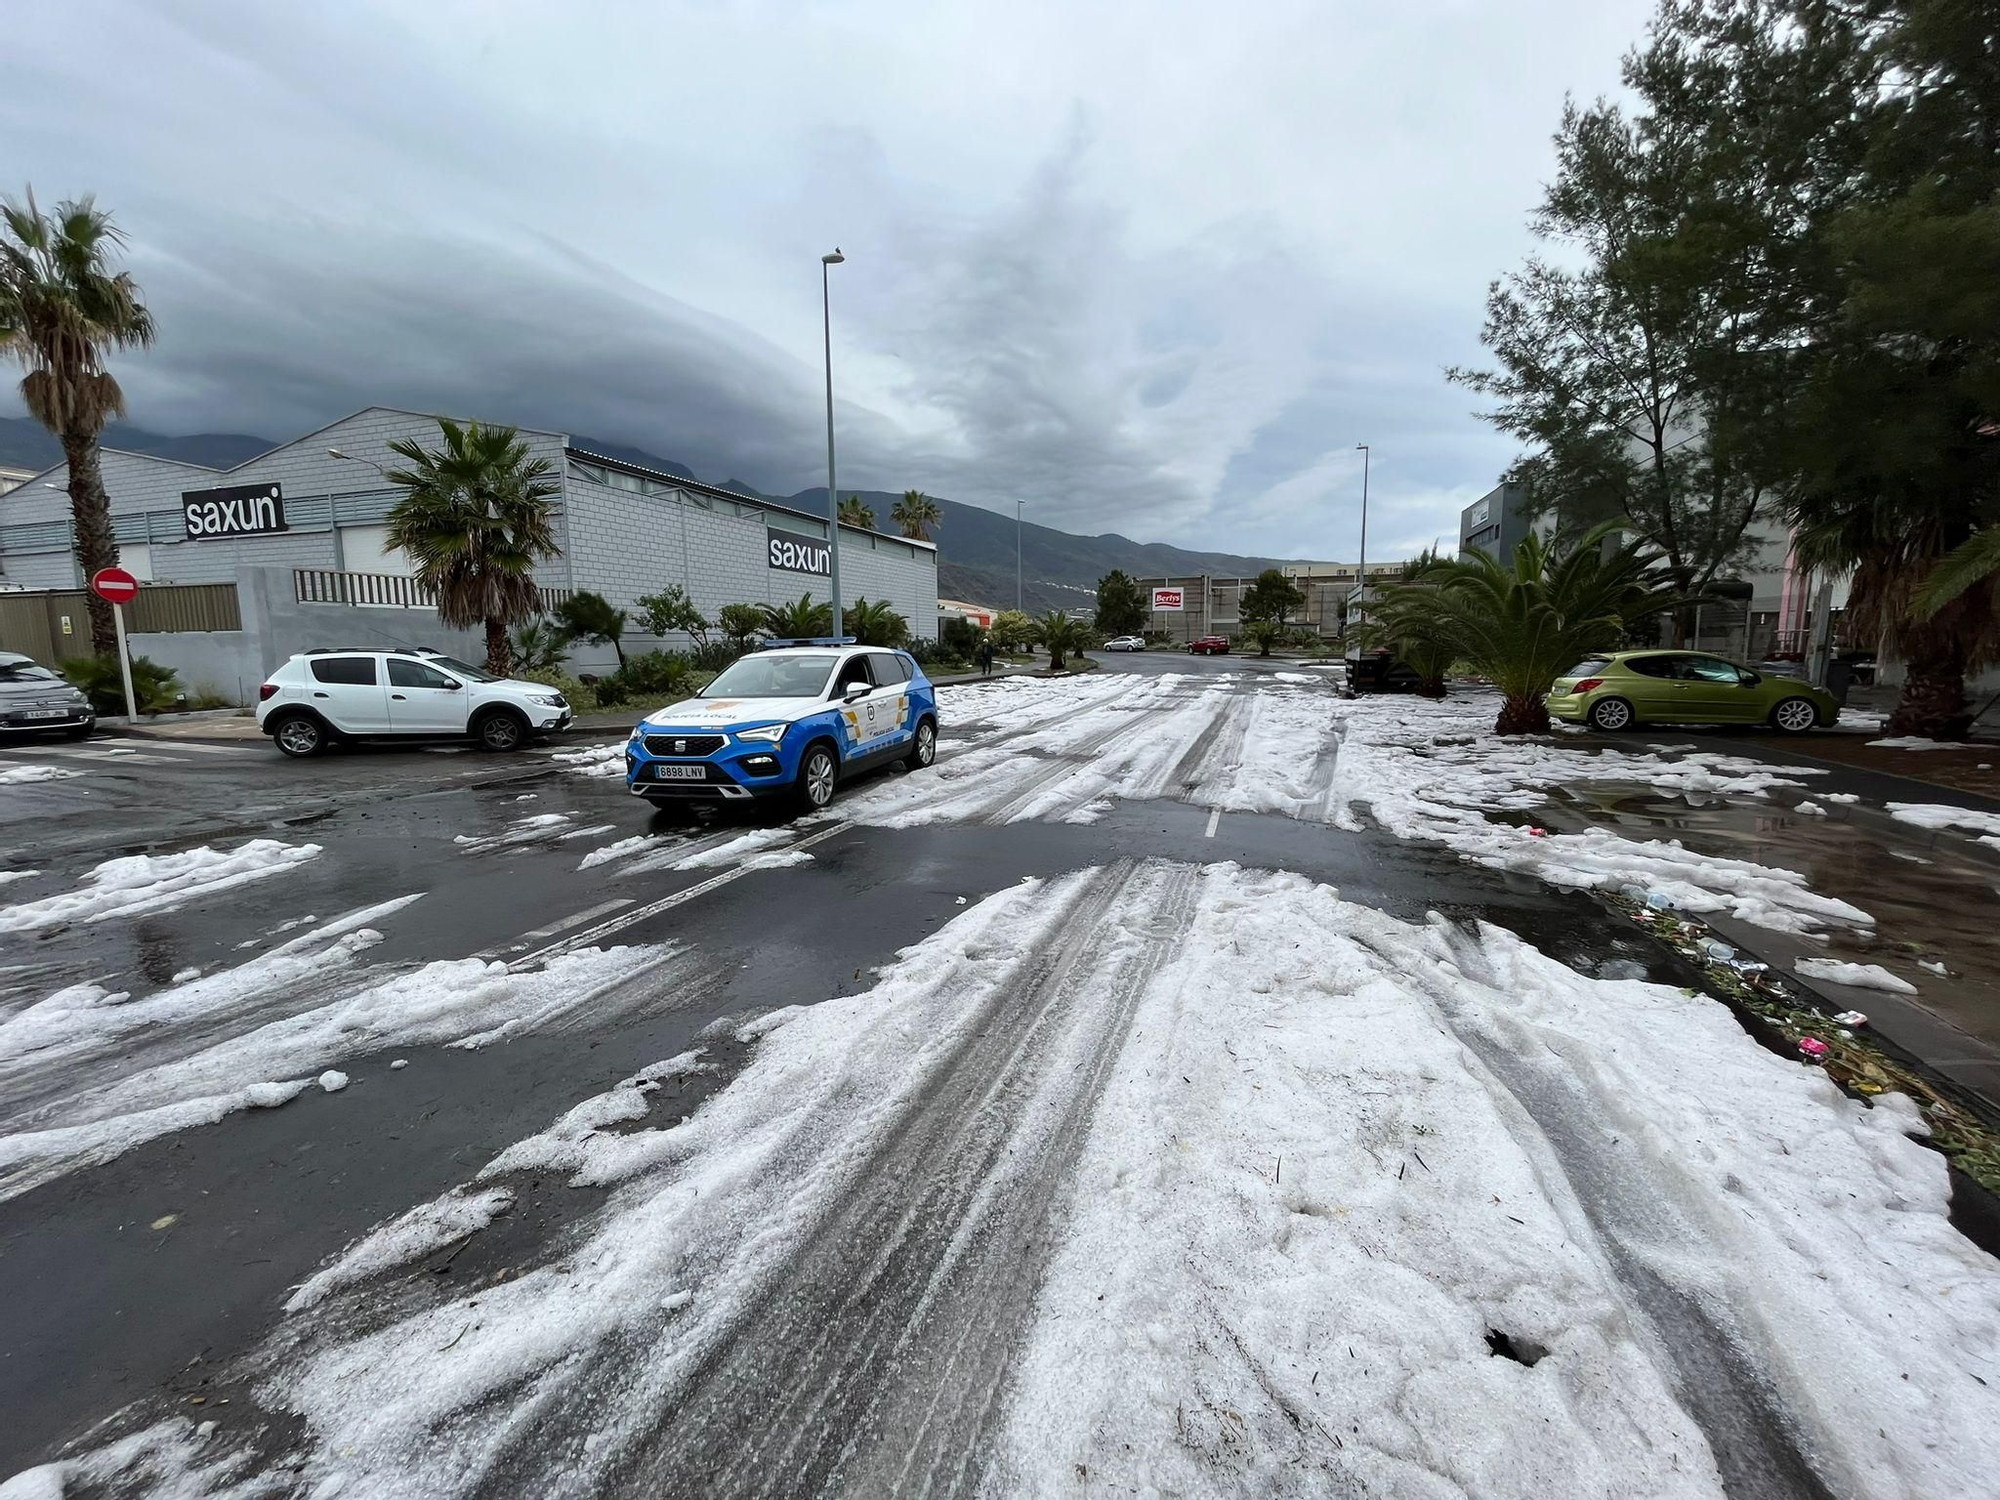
0;656;2000;1500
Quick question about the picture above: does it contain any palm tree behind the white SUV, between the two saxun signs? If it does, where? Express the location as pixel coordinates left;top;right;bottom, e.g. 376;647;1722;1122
384;416;560;676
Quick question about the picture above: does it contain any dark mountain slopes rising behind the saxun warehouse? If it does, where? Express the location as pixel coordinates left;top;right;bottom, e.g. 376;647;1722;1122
0;416;1312;610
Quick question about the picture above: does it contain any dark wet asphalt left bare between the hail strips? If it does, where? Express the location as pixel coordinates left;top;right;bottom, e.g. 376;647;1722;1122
0;656;1904;1492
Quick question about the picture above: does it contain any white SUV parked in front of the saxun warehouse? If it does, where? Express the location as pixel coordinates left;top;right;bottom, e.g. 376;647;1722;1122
256;650;570;756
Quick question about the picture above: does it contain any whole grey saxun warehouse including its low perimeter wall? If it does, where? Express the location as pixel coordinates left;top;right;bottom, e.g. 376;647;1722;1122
0;406;938;696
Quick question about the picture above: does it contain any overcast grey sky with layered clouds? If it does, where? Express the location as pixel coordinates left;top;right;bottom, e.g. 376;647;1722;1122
0;0;1652;558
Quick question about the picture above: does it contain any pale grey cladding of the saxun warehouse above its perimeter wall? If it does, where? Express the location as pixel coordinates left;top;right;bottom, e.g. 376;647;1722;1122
0;406;938;670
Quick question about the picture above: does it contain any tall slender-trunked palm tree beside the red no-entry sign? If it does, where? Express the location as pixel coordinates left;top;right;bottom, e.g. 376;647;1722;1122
0;188;152;656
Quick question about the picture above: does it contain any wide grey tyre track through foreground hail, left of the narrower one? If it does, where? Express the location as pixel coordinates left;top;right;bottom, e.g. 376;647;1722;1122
610;862;1196;1496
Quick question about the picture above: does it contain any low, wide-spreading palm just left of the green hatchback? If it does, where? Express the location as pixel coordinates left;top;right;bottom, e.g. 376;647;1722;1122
1370;524;1688;734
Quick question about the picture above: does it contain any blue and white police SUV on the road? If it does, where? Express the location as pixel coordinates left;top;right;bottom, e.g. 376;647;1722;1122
626;646;938;808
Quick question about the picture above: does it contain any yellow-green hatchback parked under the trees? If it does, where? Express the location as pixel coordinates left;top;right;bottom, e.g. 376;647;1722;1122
1548;650;1840;734
